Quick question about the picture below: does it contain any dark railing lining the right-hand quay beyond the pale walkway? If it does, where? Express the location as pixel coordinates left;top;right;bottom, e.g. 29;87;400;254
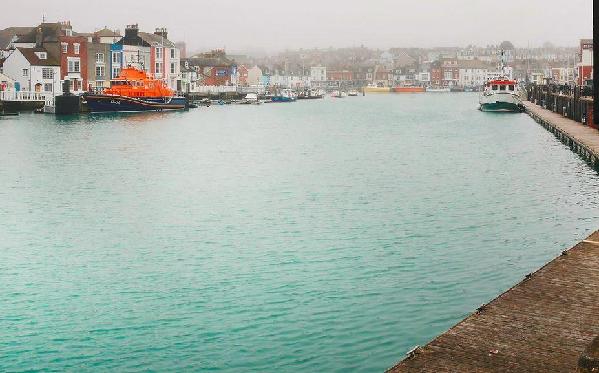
526;84;595;127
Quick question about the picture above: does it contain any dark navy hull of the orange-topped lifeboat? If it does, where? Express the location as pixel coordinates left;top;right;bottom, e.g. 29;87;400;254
85;95;187;113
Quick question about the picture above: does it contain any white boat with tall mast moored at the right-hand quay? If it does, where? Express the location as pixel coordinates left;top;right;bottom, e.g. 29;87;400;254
478;51;524;113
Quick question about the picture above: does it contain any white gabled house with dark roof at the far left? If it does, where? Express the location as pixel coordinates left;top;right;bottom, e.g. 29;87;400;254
3;48;62;94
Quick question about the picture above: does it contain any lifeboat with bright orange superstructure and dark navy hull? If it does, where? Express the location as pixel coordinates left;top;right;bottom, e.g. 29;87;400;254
84;66;187;113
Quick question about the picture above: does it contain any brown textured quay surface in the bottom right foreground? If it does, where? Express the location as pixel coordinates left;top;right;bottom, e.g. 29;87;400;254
389;231;599;372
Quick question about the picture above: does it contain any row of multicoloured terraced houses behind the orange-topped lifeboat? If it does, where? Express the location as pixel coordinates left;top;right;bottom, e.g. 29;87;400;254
0;22;181;94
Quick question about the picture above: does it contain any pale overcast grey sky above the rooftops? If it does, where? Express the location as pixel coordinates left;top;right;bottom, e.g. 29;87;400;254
0;0;593;52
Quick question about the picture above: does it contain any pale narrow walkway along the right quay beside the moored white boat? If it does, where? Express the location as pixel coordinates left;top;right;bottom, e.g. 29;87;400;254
524;101;599;170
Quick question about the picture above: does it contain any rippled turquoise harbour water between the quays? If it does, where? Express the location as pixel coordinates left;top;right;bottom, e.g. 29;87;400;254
0;93;599;372
